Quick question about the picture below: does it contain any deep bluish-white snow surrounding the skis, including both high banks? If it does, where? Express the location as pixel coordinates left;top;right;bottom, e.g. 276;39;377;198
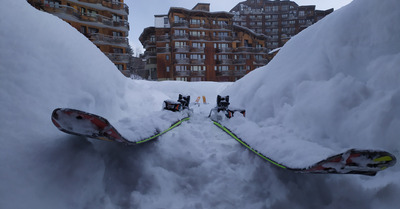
0;0;400;209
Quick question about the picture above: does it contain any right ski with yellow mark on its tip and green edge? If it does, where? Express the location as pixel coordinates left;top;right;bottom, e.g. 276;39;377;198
213;121;397;176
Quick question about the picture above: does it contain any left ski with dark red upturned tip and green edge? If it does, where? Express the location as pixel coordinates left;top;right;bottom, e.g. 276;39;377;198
51;108;189;145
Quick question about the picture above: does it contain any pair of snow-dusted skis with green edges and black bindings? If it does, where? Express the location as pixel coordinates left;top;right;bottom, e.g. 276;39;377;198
51;97;396;176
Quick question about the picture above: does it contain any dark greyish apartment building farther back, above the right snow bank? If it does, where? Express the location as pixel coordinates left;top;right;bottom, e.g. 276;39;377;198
230;0;333;50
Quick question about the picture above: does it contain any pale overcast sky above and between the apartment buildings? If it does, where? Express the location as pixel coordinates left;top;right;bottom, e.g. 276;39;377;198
124;0;353;53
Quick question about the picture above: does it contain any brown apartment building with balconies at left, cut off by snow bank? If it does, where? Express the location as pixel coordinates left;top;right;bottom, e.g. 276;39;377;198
27;0;130;76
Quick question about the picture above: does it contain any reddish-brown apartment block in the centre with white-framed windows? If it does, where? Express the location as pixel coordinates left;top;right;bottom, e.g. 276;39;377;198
139;3;268;81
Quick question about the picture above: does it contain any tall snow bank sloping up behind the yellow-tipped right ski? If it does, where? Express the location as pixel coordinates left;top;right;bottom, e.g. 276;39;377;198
226;0;400;153
